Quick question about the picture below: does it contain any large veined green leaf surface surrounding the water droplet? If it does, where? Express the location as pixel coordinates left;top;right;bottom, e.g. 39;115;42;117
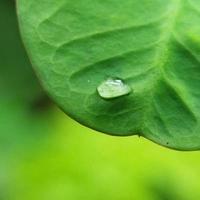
18;0;200;150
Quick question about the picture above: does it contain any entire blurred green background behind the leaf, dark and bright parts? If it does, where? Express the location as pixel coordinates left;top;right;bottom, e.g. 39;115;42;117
0;0;200;200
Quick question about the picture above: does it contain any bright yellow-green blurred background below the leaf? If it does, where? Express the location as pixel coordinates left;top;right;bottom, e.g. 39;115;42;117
7;112;200;200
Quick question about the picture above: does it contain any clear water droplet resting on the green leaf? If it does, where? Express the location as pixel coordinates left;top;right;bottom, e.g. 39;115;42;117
97;78;131;99
